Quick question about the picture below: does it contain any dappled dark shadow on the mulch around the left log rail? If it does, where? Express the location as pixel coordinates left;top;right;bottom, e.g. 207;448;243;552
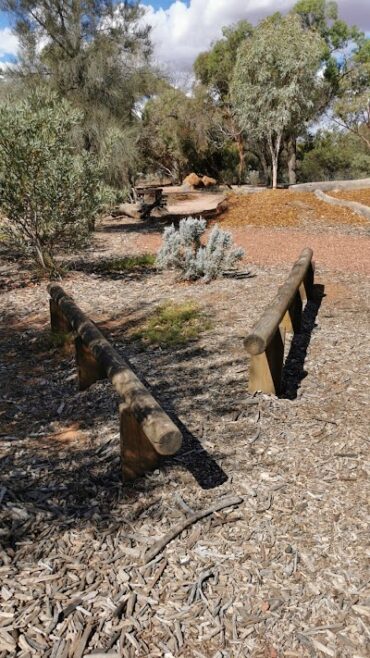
0;304;231;550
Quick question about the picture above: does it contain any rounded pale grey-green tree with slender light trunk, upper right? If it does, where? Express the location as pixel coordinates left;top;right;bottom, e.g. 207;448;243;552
231;15;322;188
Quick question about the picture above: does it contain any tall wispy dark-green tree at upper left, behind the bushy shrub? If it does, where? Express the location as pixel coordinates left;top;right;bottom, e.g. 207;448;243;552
0;0;157;187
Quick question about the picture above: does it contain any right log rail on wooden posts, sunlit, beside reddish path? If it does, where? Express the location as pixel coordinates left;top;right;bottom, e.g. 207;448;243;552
244;248;314;394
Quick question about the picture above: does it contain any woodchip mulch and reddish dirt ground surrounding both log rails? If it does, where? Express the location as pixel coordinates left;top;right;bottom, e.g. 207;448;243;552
0;195;370;658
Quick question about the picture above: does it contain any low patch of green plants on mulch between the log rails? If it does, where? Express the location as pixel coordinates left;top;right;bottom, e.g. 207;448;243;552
132;301;211;347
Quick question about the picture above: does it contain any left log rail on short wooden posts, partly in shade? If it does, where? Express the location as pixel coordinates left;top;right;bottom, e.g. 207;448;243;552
48;283;182;480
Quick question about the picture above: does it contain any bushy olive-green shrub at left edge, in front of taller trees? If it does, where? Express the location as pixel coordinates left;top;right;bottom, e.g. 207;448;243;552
0;93;100;270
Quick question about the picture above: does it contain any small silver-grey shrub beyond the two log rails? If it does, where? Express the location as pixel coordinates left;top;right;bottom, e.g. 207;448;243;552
157;217;244;281
